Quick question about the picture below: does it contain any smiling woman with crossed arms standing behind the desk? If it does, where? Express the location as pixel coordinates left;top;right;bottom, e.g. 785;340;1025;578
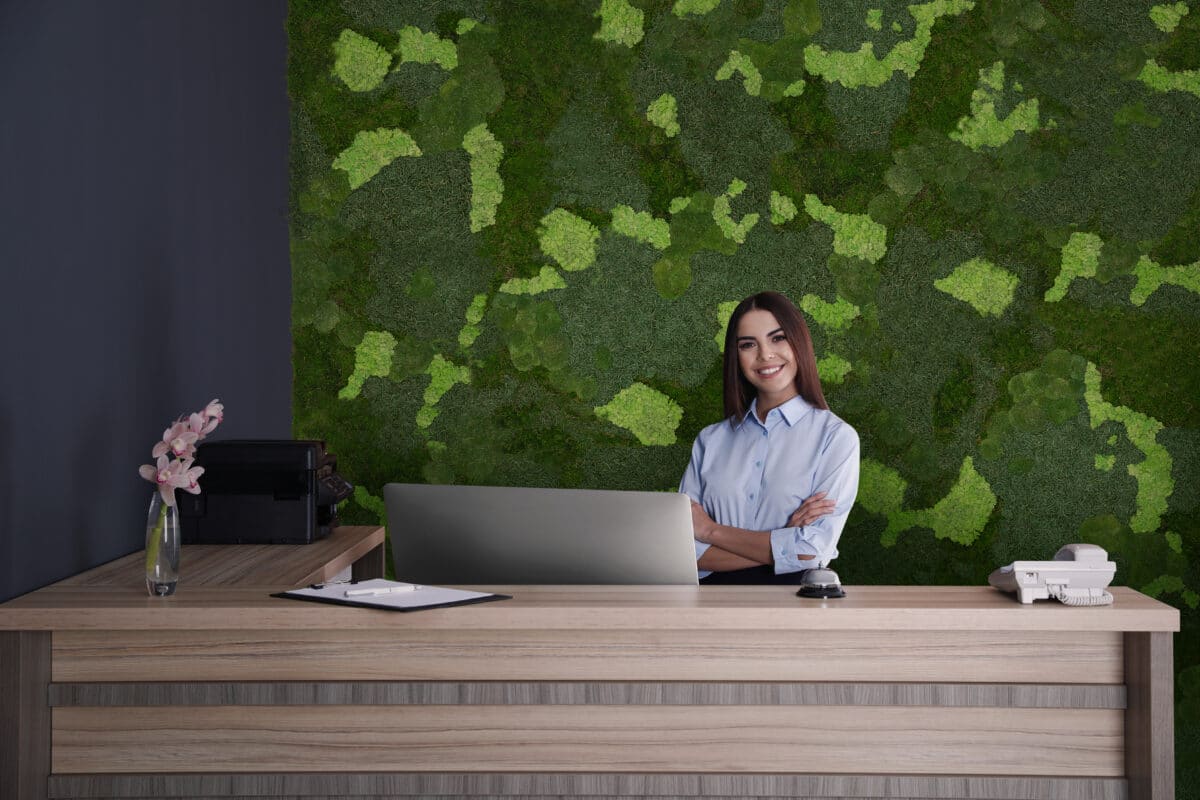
679;291;858;583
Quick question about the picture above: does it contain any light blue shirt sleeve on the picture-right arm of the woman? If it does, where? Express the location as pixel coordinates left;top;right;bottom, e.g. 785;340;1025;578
770;423;858;575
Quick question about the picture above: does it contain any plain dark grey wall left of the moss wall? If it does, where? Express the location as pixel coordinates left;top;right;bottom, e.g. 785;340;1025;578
0;0;292;601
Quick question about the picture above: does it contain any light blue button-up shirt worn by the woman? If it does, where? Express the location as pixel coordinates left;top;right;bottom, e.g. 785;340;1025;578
679;397;858;578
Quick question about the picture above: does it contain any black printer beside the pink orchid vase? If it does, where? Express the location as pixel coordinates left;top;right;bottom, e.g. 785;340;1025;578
175;439;354;545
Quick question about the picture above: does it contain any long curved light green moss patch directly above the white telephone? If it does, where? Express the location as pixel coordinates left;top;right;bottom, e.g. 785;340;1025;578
1084;362;1175;534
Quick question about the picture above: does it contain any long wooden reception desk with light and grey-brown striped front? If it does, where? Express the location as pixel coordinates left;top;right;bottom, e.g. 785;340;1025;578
0;532;1180;799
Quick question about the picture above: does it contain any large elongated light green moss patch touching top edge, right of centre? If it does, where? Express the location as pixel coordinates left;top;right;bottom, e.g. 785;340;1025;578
804;0;974;89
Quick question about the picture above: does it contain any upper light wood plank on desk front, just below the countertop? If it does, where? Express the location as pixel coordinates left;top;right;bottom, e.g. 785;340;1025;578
53;628;1124;684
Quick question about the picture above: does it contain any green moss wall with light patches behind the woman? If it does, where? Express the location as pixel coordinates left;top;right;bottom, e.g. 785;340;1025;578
288;0;1200;788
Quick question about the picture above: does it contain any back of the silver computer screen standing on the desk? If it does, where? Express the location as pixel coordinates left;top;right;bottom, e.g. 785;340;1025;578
383;483;697;585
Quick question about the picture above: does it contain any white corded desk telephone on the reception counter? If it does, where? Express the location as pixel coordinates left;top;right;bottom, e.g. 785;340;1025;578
988;545;1117;606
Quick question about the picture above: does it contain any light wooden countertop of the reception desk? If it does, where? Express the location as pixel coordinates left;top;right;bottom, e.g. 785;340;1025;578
0;581;1180;638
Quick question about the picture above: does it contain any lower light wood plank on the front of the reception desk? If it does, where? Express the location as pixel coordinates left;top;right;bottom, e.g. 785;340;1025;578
53;705;1124;777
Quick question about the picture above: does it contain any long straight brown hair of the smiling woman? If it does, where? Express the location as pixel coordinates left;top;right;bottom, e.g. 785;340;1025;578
725;291;829;425
